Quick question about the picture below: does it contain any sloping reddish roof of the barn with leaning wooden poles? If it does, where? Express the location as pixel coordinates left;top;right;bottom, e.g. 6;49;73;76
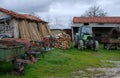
0;8;47;23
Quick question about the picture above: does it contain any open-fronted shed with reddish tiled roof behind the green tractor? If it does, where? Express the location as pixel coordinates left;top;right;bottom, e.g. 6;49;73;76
72;17;120;40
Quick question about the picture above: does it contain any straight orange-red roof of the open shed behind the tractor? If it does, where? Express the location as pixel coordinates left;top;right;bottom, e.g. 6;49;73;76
73;17;120;23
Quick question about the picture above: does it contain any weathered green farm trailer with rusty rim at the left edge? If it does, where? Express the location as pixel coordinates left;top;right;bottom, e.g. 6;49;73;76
0;40;25;74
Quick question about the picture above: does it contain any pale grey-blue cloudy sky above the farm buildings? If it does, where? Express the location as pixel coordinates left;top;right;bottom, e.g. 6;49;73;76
0;0;120;29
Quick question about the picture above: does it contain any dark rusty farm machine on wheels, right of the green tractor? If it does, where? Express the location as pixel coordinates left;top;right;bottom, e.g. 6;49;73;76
101;28;120;50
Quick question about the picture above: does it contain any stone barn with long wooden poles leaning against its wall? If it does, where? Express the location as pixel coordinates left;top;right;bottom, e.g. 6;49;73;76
0;8;51;40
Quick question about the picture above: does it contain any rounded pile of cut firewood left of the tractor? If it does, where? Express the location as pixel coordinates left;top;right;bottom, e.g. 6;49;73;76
55;32;71;49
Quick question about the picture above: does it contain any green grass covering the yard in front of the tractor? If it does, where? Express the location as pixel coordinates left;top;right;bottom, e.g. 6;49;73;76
0;45;120;78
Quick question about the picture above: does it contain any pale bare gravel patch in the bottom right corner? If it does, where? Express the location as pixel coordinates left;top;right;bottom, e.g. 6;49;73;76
87;61;120;78
